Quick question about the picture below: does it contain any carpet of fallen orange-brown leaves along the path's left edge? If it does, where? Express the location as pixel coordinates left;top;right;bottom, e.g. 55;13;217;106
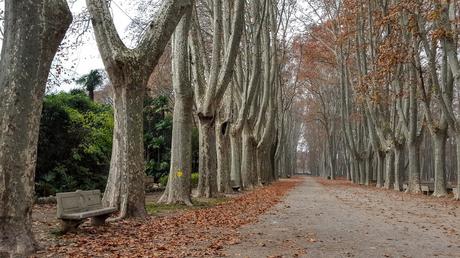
46;178;302;257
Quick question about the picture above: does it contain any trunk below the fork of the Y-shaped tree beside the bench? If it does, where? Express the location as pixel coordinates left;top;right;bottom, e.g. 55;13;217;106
103;80;147;217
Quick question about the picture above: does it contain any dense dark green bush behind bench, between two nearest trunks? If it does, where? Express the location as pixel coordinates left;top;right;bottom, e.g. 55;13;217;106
35;90;113;196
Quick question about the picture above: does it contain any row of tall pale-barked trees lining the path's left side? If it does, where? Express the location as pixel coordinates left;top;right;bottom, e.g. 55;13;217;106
0;0;300;256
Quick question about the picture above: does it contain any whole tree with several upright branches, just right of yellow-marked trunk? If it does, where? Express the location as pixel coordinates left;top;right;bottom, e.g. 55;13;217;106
191;0;245;197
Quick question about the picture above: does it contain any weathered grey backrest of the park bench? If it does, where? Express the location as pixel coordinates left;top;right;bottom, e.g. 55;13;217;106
56;190;102;218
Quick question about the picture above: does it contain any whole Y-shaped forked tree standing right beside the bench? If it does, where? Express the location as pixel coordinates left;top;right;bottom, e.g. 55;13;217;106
86;0;190;218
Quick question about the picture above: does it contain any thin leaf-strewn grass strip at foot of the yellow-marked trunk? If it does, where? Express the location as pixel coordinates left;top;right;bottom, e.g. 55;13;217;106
145;197;230;215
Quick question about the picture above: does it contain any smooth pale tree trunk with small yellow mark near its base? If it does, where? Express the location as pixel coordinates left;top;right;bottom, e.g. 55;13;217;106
159;10;193;205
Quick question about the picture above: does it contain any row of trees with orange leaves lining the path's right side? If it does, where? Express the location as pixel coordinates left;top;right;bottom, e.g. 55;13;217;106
297;0;460;199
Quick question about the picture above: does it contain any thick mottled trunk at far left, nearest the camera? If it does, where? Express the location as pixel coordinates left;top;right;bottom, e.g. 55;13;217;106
0;0;72;257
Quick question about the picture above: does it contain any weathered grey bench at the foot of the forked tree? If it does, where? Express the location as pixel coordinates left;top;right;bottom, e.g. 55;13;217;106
56;190;117;233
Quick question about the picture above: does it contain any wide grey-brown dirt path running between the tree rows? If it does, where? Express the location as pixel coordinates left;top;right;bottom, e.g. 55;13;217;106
225;177;460;258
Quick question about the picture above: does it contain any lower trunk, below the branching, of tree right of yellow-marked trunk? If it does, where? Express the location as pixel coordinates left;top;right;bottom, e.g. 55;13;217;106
197;116;217;198
